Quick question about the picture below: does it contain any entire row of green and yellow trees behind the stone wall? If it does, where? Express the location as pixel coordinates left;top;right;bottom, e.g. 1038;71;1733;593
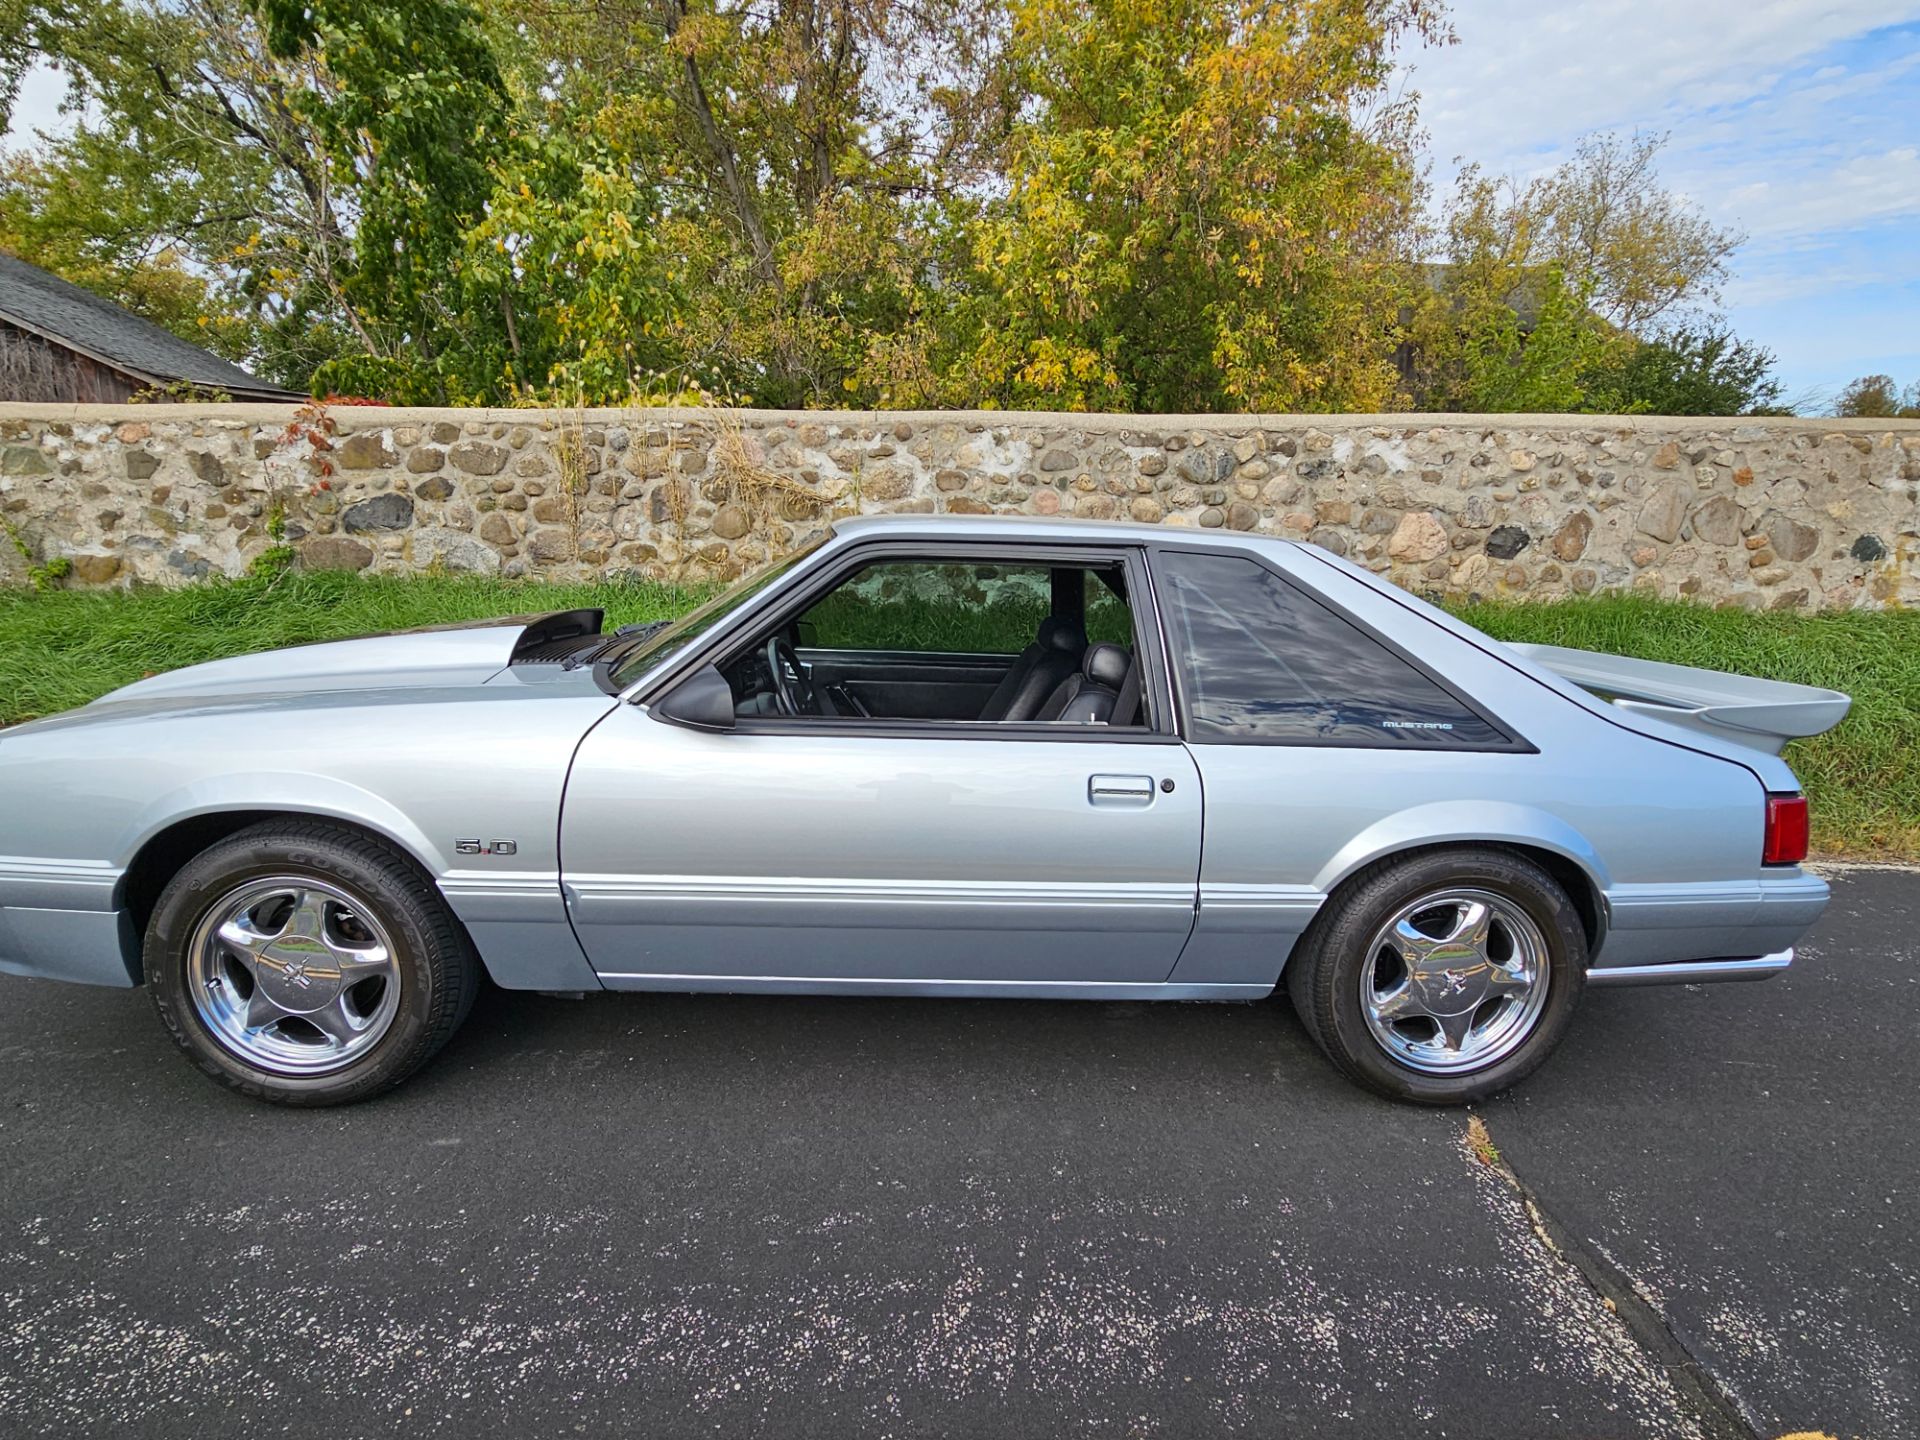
0;0;1797;413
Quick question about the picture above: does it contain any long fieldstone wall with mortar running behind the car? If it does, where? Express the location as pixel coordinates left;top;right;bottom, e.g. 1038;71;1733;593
0;405;1920;609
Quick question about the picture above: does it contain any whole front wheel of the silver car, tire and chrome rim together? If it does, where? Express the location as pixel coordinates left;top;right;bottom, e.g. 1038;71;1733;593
146;822;480;1106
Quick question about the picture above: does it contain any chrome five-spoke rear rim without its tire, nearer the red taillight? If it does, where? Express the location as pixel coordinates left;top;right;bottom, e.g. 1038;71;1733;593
1359;889;1551;1075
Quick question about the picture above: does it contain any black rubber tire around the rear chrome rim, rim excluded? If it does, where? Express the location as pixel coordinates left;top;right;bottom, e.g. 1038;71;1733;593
1286;847;1588;1106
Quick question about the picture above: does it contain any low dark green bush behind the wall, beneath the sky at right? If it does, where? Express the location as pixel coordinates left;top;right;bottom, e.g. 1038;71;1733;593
1584;323;1782;415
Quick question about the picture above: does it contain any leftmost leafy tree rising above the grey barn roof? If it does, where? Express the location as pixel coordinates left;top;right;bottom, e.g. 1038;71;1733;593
8;0;371;386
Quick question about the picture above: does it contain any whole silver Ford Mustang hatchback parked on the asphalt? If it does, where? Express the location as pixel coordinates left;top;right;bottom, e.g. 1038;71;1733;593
0;516;1847;1104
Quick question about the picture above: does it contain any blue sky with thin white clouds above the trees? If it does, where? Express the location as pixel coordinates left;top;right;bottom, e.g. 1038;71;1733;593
10;0;1920;409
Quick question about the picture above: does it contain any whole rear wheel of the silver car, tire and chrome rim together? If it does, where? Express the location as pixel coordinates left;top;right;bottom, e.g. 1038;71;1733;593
1286;847;1588;1104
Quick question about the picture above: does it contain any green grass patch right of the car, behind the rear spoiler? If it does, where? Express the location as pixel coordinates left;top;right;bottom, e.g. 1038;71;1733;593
1455;595;1920;858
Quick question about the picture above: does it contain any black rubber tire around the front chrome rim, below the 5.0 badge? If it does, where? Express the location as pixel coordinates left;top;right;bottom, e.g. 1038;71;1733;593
144;820;482;1106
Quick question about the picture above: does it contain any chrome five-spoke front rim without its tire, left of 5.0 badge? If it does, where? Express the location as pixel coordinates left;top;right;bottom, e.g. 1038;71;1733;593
186;876;401;1075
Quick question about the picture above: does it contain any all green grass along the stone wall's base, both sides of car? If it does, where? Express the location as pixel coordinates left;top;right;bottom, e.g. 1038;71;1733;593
0;570;1920;856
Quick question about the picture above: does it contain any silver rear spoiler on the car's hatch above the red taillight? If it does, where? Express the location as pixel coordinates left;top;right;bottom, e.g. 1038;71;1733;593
1507;645;1853;755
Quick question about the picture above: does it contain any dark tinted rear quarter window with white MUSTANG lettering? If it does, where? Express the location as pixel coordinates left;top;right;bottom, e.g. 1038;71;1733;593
1156;553;1507;749
